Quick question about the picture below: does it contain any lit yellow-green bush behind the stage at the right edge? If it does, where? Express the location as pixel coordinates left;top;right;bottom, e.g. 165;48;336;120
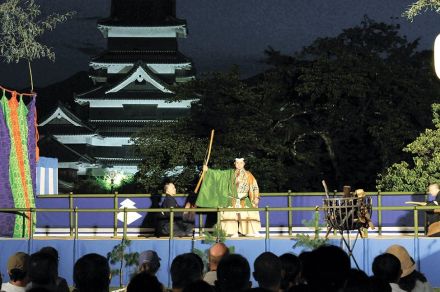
378;104;440;192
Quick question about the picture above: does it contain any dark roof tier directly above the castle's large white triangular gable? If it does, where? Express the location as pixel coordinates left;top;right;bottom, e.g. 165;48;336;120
90;50;191;64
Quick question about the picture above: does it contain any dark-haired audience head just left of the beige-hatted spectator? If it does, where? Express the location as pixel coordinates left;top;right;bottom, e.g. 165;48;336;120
373;253;402;283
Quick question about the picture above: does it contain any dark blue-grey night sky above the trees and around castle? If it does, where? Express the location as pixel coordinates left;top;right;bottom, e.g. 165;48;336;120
0;0;440;89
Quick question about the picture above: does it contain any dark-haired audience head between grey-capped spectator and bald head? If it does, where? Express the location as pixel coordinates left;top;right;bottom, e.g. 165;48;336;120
170;253;203;289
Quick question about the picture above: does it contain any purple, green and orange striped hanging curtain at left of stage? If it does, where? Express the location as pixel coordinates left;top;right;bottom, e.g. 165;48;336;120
0;90;36;237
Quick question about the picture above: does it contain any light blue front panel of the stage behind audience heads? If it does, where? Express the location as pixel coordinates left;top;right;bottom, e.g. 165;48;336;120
0;236;440;287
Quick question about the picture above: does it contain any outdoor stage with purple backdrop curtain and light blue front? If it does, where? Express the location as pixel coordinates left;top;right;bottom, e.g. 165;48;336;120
0;193;440;287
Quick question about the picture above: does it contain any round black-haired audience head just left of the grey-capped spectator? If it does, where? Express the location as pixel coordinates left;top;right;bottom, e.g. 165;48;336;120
73;253;110;292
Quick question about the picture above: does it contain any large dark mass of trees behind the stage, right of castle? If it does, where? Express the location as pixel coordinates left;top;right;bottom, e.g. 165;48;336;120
136;17;440;191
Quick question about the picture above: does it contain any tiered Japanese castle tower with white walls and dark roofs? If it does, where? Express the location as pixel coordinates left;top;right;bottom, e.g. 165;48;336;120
40;0;194;175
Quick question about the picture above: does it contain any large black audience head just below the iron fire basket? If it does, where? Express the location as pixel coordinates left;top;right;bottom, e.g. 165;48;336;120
303;245;350;291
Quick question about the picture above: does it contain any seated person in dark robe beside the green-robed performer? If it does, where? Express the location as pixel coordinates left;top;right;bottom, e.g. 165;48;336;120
156;183;194;237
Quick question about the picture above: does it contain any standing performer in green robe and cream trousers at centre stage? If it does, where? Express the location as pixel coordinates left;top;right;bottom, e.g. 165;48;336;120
196;158;261;238
